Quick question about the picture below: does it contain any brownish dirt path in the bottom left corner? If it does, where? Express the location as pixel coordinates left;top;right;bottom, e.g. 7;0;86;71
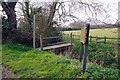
1;67;17;78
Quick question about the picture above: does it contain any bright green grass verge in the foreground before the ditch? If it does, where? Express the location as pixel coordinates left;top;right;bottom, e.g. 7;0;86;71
2;43;118;80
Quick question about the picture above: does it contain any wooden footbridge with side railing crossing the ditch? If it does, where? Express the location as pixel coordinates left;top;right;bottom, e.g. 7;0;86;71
37;36;73;54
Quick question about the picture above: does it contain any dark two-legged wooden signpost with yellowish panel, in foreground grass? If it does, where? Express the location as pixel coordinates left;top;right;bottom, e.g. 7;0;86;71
80;24;90;74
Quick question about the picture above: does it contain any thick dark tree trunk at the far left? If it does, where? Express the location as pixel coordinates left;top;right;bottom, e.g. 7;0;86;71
1;1;17;31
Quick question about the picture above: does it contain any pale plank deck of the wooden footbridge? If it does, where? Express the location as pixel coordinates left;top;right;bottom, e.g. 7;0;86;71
38;43;72;50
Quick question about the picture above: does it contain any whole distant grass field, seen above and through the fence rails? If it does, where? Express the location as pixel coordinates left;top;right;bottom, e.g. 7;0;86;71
63;28;119;45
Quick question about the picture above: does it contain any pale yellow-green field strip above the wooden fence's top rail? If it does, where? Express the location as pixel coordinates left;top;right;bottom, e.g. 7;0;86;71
63;28;118;38
